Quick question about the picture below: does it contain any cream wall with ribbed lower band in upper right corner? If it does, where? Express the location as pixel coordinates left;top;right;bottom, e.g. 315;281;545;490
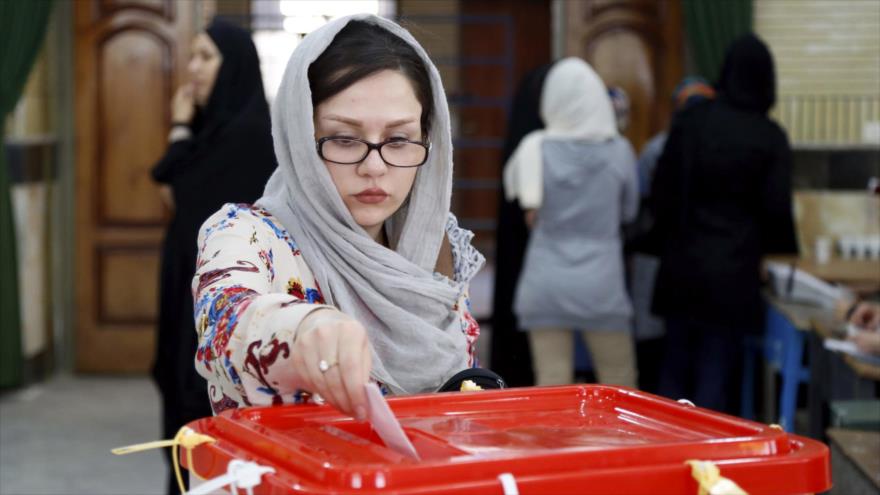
754;0;880;147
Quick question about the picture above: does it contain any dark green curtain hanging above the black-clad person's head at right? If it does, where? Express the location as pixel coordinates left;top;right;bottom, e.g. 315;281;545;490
682;0;752;82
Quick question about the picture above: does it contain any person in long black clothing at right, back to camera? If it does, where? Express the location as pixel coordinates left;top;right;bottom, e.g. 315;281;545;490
651;34;797;412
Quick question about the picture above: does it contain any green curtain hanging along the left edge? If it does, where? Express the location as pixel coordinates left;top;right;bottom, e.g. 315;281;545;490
0;0;52;388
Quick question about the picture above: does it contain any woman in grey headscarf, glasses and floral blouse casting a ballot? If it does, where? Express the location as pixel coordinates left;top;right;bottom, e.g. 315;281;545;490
193;15;484;419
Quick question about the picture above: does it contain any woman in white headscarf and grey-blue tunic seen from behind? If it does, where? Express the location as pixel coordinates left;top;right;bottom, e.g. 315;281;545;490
504;57;638;387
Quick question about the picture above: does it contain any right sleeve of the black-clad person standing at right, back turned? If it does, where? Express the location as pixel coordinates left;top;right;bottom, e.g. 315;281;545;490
761;129;798;254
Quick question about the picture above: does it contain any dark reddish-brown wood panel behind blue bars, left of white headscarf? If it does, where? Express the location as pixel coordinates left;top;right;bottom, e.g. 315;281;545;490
453;0;551;248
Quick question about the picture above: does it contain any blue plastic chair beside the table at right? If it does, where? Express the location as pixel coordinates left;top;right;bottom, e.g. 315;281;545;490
740;305;810;431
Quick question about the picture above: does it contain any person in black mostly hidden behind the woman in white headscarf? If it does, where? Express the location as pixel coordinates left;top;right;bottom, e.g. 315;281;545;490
490;64;552;387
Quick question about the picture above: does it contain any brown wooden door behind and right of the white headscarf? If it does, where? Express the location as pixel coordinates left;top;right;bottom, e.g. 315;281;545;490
563;0;683;151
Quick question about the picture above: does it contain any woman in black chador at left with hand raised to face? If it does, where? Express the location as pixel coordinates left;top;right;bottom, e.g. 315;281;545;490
152;20;276;493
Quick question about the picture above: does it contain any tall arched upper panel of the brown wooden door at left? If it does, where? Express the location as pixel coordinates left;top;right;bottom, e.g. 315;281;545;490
95;27;174;225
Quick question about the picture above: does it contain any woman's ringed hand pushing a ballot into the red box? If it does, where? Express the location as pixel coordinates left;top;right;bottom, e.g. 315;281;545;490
291;309;372;420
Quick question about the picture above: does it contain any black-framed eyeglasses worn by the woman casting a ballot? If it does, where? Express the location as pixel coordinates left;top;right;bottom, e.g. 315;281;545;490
316;136;431;168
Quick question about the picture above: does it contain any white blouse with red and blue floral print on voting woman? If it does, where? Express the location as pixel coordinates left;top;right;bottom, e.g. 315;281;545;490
192;204;480;414
